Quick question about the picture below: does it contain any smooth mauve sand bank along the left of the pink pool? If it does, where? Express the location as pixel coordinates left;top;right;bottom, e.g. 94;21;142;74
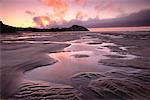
1;32;78;98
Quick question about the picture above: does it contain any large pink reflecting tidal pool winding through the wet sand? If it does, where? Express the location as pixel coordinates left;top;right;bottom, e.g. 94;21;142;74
25;37;138;84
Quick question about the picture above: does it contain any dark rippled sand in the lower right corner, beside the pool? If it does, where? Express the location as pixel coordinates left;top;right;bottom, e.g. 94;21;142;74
71;70;150;100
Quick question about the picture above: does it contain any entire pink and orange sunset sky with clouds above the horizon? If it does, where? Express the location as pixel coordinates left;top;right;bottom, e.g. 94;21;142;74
0;0;150;28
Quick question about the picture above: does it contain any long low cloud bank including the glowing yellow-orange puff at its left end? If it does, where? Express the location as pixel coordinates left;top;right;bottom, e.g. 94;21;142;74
34;9;150;28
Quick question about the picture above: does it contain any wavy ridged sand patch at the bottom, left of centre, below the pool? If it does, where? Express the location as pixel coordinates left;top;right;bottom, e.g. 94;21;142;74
13;81;82;100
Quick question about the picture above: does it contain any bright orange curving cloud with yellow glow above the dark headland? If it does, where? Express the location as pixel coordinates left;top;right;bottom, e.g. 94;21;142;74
32;0;69;28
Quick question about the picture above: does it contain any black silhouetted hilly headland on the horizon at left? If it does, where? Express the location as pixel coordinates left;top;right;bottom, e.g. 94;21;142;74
0;21;89;34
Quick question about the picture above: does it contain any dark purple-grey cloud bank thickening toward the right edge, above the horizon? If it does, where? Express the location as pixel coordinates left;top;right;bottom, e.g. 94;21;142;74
59;9;150;28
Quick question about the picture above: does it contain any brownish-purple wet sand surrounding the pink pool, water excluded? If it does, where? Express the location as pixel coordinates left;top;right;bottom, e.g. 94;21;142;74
1;33;150;100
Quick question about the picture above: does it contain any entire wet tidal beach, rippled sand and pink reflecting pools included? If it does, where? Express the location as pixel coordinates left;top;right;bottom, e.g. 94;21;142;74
0;32;150;100
